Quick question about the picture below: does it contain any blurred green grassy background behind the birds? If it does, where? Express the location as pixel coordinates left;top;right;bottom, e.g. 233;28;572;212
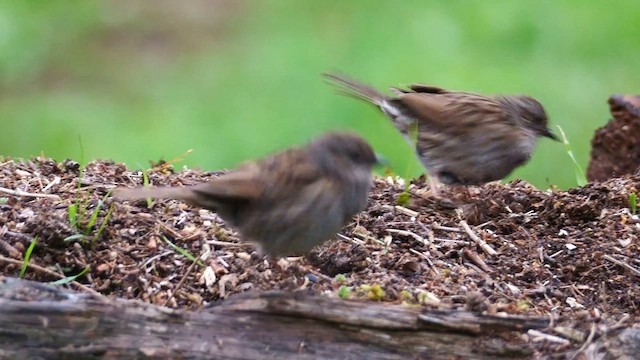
0;0;640;188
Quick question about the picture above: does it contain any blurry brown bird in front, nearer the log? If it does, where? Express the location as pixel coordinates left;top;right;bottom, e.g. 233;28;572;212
114;132;377;257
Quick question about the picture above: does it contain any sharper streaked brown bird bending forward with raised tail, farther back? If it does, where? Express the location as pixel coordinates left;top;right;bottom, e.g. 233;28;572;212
324;74;558;195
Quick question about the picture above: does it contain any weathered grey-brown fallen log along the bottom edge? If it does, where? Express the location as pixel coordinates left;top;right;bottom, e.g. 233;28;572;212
0;278;549;359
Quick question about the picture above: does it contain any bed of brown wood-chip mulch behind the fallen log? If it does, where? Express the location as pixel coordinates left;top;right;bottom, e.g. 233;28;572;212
0;158;640;349
